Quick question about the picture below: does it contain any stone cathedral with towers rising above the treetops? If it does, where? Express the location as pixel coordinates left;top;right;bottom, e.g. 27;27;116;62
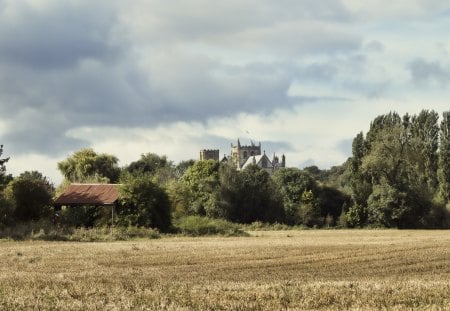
200;139;286;174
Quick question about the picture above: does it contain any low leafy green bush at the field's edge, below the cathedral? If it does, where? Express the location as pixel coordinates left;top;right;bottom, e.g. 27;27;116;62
176;216;246;236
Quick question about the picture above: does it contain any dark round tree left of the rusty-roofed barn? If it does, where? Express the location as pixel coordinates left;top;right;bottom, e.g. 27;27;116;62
5;171;54;221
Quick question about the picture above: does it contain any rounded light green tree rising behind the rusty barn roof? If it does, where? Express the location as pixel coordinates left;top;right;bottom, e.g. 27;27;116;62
58;148;120;183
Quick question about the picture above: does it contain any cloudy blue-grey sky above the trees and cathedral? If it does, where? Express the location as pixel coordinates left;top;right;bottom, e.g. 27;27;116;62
0;0;450;184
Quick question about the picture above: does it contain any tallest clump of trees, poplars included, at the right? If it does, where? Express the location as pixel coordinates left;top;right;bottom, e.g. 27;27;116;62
346;110;445;228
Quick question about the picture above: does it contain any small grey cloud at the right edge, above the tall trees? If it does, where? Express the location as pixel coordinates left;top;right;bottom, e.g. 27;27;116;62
408;58;450;84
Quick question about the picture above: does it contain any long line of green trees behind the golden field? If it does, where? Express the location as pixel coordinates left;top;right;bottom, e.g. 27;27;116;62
0;110;450;231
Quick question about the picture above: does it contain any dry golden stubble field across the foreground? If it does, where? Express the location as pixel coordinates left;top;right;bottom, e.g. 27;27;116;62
0;230;450;310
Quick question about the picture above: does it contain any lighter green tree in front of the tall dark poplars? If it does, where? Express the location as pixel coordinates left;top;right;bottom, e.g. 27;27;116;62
362;124;431;227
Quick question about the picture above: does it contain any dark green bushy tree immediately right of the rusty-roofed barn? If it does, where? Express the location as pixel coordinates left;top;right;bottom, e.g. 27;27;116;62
117;174;171;231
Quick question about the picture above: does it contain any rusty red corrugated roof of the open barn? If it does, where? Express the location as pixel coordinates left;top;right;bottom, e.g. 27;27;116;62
55;184;119;206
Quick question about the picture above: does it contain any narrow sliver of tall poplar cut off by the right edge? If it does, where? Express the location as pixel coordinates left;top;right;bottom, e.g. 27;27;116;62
438;111;450;202
